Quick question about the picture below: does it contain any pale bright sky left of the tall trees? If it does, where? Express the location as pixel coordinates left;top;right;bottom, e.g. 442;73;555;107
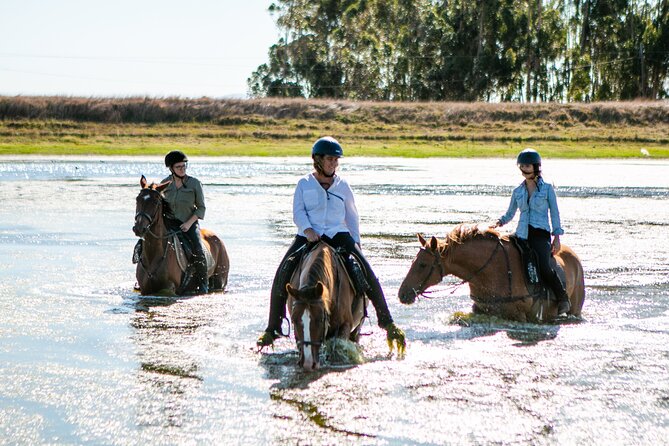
0;0;279;98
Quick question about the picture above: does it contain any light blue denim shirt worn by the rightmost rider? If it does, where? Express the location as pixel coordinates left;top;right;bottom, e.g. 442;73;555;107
499;177;564;239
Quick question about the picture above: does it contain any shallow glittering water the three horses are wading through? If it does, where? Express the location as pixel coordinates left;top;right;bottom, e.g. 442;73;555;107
0;158;669;445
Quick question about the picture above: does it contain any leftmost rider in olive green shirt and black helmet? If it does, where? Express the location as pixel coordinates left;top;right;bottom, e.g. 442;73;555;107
162;150;208;294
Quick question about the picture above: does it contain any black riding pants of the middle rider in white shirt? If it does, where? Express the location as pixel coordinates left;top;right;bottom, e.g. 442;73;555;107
266;232;393;332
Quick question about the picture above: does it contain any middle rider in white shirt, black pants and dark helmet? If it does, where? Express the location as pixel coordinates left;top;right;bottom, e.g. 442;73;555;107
257;136;404;348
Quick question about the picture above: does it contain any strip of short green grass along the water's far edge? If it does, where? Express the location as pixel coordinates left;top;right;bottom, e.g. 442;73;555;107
0;139;669;158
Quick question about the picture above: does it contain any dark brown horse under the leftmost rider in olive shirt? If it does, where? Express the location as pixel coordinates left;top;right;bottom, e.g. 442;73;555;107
132;175;230;296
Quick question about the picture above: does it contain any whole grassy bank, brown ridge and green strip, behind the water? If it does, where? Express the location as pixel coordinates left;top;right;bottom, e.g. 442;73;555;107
0;97;669;158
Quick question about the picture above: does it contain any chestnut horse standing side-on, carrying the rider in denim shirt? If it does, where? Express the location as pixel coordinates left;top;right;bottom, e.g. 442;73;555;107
399;225;585;322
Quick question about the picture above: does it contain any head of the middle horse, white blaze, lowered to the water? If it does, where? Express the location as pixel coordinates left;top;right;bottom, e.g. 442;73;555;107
286;281;329;370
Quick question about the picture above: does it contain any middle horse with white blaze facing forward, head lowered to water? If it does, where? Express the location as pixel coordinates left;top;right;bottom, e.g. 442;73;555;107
286;241;366;370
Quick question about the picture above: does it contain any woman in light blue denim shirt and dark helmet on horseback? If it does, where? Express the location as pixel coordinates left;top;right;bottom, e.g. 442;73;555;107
493;149;570;314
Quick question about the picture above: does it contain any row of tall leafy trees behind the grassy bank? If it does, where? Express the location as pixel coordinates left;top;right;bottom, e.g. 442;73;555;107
248;0;669;102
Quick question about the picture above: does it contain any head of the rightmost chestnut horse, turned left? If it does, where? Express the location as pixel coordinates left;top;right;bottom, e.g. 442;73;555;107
399;234;446;304
